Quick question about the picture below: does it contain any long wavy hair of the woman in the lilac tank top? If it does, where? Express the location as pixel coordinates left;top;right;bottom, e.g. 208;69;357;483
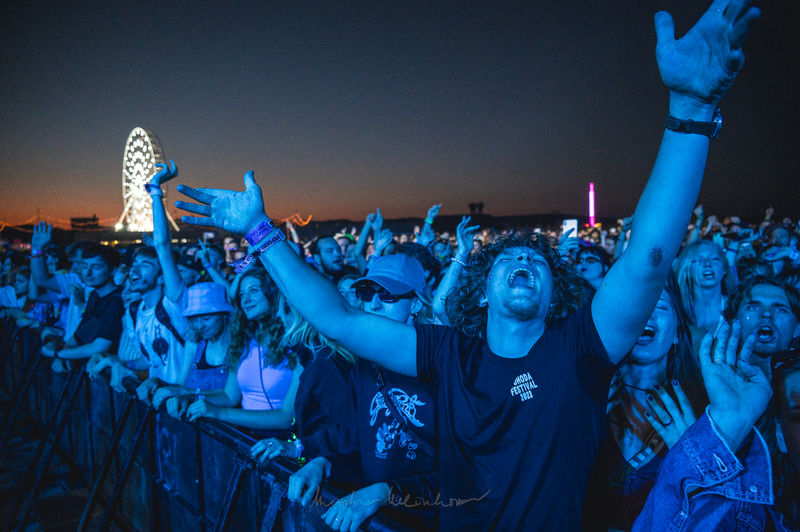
225;268;296;370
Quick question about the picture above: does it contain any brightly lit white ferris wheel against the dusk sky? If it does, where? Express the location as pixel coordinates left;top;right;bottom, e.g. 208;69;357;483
116;127;179;232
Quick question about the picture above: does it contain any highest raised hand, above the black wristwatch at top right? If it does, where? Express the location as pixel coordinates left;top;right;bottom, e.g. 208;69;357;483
655;0;761;106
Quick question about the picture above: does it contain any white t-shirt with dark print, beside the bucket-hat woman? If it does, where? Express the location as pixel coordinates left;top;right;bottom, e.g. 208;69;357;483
136;290;189;384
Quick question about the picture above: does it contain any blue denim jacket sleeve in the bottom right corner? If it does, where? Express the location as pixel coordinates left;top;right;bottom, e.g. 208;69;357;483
633;410;788;531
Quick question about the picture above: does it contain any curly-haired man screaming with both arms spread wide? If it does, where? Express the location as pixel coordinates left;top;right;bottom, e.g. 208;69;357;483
178;0;759;530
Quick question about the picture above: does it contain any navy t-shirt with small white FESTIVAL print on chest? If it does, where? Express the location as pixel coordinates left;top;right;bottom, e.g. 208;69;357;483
416;305;614;530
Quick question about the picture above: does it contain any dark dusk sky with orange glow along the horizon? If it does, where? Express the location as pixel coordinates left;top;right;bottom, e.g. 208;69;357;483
0;0;800;229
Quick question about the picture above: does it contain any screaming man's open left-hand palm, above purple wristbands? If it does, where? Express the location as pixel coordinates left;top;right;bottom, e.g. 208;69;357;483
175;171;267;235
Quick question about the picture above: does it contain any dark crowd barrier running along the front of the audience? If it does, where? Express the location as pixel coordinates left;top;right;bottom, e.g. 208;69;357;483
0;320;408;532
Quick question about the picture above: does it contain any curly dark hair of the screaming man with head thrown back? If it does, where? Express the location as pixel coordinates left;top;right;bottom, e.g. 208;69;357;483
445;231;587;339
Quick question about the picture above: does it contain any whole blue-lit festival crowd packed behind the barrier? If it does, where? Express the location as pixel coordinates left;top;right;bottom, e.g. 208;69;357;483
0;0;800;530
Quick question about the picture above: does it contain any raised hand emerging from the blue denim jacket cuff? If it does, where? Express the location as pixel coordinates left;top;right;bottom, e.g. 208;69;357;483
699;321;772;450
